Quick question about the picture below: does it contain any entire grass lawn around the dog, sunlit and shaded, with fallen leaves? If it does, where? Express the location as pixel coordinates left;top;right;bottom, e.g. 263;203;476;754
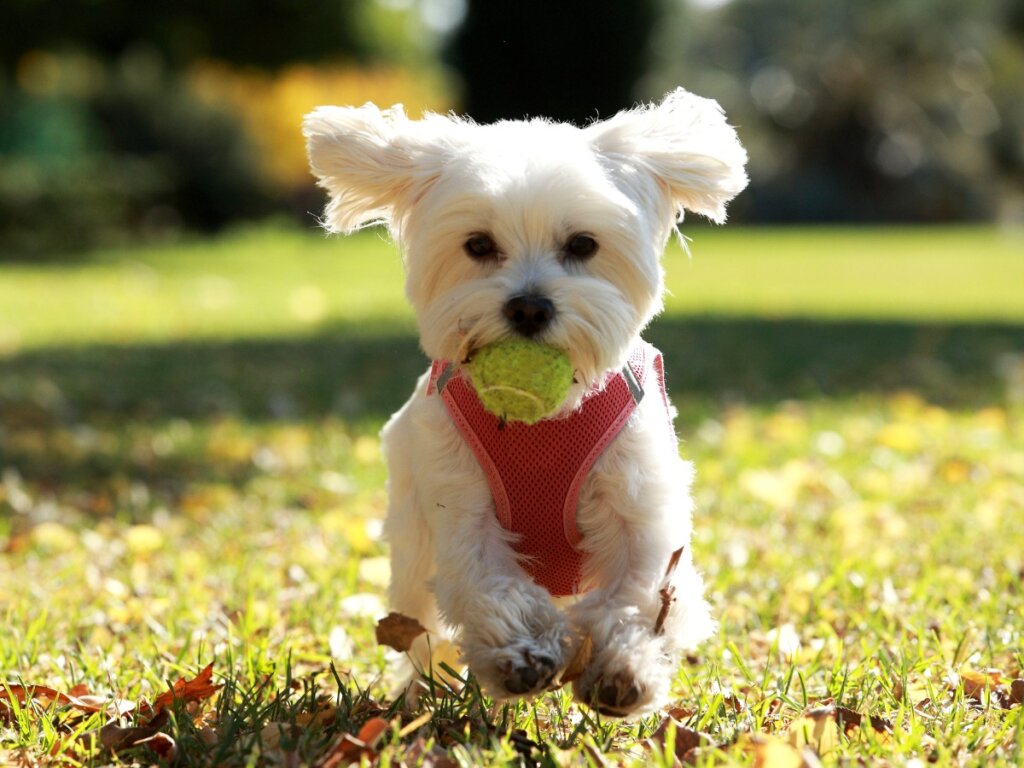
0;228;1024;766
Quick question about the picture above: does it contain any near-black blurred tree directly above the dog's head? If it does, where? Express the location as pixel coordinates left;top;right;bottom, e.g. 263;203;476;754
450;0;657;123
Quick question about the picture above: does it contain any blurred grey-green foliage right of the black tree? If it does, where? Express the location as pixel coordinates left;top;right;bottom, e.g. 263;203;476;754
642;0;1024;221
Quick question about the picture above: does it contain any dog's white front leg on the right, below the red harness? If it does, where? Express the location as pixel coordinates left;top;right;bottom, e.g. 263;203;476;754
572;429;714;717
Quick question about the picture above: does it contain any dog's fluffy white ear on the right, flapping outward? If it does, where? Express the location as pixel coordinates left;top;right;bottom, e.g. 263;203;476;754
586;88;746;223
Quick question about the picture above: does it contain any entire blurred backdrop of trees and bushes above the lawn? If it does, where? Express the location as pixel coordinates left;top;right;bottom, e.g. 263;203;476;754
0;0;1024;260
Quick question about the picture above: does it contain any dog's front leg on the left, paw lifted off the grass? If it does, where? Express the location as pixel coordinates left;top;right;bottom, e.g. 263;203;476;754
425;496;570;698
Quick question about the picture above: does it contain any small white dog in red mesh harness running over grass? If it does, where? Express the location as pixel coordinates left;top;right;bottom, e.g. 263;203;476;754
304;89;746;717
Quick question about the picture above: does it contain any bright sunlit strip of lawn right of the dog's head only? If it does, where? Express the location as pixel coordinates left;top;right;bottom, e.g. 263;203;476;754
666;227;1024;322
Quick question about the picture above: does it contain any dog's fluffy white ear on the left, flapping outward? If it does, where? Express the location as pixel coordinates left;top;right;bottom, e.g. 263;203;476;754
302;103;445;232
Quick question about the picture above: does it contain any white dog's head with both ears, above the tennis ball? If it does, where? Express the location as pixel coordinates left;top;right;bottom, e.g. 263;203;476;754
305;90;746;383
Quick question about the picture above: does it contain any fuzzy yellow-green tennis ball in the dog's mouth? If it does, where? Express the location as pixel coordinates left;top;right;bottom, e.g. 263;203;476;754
469;338;572;424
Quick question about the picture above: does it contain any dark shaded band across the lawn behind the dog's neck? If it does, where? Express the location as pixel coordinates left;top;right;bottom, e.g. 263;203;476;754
0;317;1024;493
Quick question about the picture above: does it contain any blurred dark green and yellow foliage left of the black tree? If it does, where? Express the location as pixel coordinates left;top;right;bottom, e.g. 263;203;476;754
0;0;447;259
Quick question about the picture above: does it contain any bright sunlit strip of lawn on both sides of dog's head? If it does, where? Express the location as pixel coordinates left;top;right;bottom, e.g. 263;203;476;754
0;226;1024;352
